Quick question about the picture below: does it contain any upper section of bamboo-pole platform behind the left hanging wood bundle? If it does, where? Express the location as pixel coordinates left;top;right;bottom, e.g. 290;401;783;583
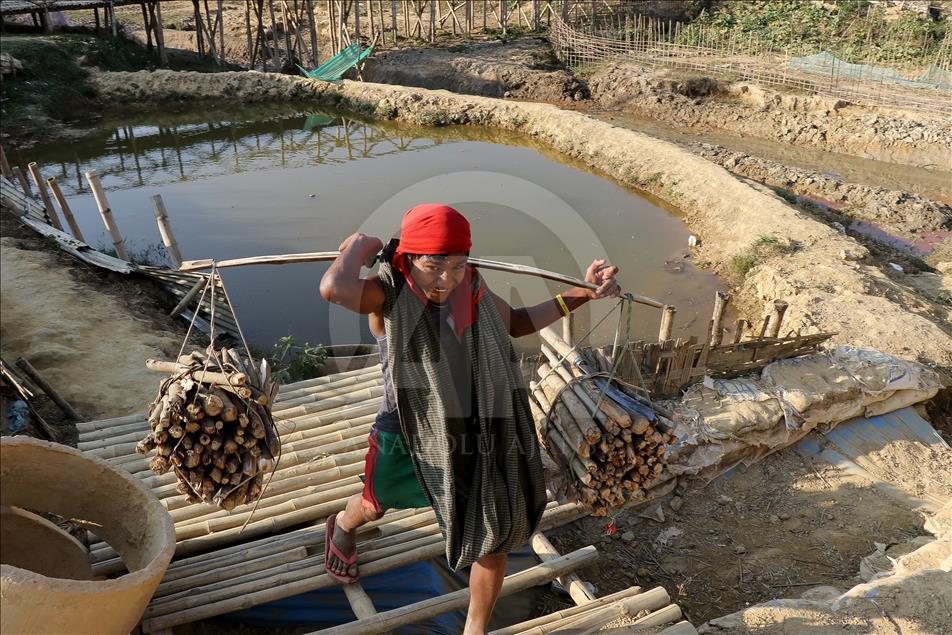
78;365;383;575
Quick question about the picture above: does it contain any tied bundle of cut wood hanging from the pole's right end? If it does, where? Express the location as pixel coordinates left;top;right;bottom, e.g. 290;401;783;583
530;328;675;516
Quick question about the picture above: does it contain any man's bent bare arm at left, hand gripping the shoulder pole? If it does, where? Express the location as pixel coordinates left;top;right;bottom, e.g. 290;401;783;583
321;232;384;314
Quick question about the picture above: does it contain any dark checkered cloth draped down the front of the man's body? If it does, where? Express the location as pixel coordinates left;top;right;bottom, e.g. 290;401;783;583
379;263;546;570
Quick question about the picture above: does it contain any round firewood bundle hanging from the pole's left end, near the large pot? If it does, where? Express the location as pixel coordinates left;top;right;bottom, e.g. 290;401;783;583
136;347;280;511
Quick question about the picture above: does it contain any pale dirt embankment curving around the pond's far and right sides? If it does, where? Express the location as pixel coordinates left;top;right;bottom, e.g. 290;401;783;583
89;71;952;380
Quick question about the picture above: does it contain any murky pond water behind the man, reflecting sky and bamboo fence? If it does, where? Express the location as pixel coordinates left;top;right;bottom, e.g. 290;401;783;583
10;107;726;351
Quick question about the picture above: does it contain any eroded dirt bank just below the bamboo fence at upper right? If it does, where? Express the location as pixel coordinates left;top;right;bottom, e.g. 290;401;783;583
587;64;952;171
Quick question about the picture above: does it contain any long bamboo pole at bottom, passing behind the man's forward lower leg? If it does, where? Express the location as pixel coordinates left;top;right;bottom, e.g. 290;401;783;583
308;546;598;635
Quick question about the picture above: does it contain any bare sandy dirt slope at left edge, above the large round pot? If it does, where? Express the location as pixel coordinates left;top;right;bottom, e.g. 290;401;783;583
0;210;184;418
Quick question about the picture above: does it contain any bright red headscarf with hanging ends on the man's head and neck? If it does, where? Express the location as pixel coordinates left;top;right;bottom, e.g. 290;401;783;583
393;203;483;337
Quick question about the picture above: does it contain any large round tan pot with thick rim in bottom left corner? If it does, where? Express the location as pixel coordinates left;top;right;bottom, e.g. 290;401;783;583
0;437;175;635
